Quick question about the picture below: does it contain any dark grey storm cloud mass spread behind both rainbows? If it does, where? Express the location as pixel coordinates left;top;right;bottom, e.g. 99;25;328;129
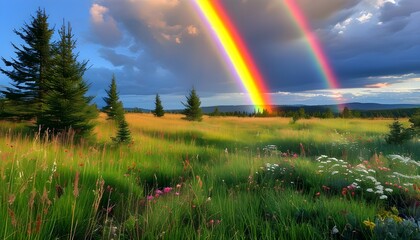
87;0;420;98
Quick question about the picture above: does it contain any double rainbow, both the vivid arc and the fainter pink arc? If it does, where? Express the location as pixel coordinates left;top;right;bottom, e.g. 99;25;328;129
194;0;338;111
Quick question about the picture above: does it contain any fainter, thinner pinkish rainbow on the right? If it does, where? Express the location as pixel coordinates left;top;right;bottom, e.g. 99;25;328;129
283;0;339;89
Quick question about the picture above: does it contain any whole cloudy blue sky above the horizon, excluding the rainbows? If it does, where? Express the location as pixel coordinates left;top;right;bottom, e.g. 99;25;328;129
0;0;420;109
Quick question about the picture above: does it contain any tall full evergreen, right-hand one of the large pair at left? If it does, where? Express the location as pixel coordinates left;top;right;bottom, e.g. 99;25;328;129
38;23;98;137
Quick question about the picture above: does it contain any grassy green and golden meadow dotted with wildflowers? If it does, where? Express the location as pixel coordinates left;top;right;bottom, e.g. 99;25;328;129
0;114;420;239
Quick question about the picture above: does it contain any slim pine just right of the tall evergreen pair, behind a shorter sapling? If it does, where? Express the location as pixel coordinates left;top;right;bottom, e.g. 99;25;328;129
102;75;123;120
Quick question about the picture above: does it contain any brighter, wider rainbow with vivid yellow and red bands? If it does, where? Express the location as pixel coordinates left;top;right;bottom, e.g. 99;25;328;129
194;0;272;111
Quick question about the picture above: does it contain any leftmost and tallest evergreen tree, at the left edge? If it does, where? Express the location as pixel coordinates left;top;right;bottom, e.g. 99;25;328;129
0;9;54;118
